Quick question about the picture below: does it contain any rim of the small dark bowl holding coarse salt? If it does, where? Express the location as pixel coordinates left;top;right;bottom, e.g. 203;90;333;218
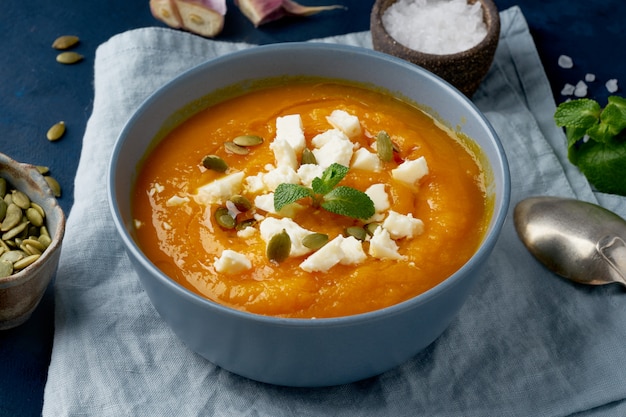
370;0;501;61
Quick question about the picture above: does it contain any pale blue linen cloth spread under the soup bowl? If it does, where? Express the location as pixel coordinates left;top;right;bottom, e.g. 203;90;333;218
43;7;626;417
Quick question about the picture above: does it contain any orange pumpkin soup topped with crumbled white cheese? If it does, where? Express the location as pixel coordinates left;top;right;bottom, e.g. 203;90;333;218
133;80;491;318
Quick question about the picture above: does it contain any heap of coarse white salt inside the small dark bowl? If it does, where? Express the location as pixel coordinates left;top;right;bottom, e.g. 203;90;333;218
382;0;487;55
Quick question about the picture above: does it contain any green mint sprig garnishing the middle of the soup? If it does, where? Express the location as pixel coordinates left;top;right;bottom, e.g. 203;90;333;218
274;163;375;220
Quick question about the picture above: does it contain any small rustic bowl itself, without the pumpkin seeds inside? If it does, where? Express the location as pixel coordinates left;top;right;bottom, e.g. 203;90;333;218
0;153;65;330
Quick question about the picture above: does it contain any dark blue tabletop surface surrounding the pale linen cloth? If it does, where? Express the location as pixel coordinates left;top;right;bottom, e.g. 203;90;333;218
0;0;626;416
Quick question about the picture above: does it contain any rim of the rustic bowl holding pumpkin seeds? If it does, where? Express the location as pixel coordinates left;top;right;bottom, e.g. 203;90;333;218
0;153;66;289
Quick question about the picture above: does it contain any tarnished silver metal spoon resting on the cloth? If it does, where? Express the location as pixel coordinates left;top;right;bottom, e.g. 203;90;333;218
513;197;626;286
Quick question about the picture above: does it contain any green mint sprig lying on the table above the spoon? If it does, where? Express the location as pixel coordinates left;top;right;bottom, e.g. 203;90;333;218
554;96;626;196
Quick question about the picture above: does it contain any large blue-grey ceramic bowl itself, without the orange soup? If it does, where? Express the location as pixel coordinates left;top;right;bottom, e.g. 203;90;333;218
108;43;510;387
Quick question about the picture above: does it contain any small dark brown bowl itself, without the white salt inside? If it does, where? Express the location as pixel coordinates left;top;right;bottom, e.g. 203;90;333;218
370;0;500;97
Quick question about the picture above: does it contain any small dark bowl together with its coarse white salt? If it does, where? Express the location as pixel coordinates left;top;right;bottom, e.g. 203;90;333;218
370;0;500;96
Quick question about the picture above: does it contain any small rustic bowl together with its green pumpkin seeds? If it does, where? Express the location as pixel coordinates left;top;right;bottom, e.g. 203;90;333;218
0;153;65;330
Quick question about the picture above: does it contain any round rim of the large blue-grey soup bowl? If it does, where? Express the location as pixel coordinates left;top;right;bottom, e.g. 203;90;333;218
106;41;511;328
